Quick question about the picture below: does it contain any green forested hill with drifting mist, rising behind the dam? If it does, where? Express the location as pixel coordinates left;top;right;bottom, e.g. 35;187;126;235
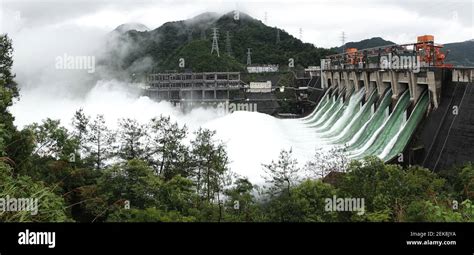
107;13;334;71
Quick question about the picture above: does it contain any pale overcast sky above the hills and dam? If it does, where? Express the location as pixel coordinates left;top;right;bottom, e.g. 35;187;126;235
0;0;474;47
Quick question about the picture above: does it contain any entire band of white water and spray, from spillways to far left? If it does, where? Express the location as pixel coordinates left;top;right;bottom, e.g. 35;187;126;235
11;81;336;184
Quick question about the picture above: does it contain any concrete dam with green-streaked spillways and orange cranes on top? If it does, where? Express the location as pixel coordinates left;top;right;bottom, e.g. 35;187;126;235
300;36;474;170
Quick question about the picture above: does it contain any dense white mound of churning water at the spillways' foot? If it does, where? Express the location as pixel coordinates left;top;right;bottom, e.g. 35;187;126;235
204;111;330;183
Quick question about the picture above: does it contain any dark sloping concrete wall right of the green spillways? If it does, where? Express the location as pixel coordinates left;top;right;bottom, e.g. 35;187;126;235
407;80;474;171
